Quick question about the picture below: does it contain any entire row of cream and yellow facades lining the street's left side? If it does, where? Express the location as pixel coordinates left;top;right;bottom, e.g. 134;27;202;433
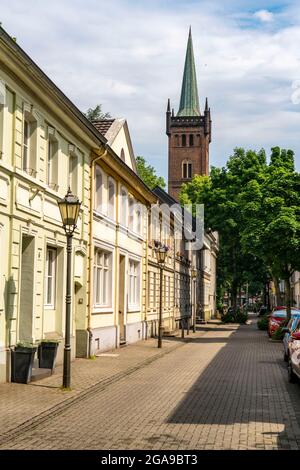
0;28;217;382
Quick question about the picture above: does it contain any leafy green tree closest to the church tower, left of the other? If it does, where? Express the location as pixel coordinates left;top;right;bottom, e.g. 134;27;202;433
181;149;266;309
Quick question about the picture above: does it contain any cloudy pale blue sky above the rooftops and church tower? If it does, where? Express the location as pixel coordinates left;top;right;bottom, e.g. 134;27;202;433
0;0;300;178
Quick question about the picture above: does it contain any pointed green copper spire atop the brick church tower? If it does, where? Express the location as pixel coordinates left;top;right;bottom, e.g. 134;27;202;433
177;28;200;116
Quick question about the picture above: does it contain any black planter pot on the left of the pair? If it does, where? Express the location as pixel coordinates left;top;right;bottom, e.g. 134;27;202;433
11;346;37;384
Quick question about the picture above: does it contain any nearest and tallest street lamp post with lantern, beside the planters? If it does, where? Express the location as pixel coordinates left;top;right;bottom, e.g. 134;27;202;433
58;187;81;388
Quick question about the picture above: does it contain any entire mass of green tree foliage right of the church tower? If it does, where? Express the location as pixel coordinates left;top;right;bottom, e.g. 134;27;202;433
180;147;300;316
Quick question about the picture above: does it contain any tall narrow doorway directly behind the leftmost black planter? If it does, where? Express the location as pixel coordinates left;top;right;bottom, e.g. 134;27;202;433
19;236;34;342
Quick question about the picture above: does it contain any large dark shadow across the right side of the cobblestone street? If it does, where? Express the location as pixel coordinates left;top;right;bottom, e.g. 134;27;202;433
167;324;300;449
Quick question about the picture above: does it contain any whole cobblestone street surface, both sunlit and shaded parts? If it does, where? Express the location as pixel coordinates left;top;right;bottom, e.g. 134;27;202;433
0;322;300;450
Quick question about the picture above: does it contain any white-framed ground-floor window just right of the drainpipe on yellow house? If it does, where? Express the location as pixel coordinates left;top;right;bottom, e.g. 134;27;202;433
94;248;112;307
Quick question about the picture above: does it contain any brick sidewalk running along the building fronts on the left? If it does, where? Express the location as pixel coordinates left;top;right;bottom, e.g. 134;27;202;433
0;323;214;438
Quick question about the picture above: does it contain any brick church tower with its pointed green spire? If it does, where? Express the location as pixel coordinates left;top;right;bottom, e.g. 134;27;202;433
166;28;211;200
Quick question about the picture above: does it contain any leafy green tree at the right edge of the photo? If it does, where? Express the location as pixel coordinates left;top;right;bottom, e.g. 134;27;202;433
242;147;300;318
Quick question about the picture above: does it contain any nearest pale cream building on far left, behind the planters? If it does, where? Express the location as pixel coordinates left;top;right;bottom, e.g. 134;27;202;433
0;29;105;382
